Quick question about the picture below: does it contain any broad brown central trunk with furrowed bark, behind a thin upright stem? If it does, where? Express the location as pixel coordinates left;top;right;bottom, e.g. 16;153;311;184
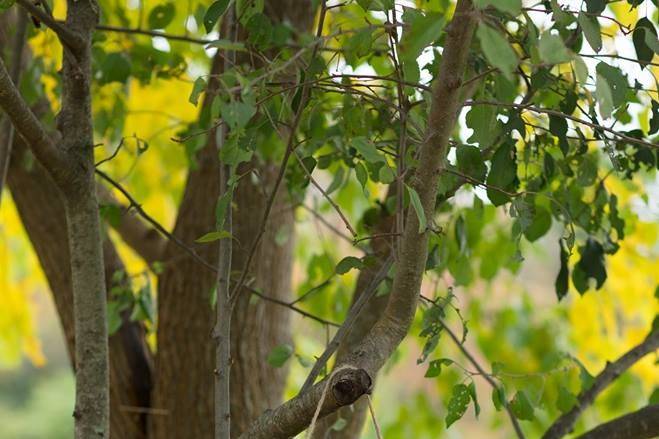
150;4;313;439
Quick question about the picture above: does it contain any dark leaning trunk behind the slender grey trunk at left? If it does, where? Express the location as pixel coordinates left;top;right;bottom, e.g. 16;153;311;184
8;140;151;439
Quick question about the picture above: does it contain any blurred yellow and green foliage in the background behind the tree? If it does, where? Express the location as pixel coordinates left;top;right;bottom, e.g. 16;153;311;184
0;1;659;439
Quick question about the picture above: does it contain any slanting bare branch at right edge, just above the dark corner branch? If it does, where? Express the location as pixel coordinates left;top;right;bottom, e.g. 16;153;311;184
542;330;659;439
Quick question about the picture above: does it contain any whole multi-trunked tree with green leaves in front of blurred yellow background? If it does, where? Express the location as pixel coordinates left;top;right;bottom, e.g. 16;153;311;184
0;0;659;439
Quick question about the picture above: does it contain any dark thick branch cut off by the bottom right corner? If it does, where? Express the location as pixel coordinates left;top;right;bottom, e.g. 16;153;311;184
577;404;659;439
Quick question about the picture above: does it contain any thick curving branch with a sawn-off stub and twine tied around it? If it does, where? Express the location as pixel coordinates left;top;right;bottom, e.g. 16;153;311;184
241;0;476;439
